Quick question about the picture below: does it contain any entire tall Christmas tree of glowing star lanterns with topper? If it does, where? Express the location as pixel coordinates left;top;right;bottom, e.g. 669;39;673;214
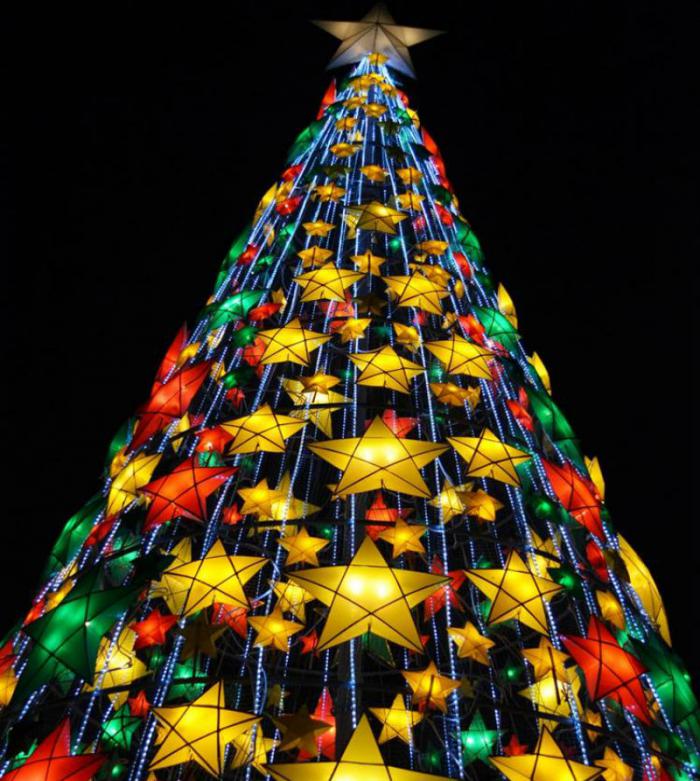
0;7;700;781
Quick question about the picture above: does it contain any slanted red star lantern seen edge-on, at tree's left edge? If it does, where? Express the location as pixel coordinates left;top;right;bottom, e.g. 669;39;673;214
129;361;211;450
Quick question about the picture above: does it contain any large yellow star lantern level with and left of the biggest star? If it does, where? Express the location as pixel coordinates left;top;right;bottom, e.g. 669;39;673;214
155;540;267;616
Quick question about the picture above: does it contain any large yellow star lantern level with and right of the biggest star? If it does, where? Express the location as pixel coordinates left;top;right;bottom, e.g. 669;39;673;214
465;551;563;635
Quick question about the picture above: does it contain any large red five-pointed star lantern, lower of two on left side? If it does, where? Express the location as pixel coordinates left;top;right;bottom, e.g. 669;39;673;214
141;456;238;532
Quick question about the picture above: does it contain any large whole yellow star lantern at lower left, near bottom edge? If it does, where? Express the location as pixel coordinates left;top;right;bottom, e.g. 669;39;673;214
148;681;260;778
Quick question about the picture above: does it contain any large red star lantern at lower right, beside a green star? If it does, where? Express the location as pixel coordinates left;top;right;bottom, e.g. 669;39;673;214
562;616;651;724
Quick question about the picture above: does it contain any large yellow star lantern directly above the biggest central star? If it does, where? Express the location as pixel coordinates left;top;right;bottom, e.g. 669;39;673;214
308;417;447;499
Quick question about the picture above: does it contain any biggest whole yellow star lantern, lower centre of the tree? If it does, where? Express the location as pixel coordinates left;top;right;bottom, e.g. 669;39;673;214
294;537;448;653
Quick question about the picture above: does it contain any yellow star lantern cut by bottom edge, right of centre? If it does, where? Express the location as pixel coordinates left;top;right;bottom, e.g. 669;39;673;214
488;727;603;781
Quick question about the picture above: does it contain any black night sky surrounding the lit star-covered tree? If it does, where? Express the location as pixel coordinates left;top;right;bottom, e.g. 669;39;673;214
0;0;700;668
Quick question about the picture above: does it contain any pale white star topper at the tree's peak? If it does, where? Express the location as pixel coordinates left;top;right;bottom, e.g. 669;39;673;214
314;3;442;77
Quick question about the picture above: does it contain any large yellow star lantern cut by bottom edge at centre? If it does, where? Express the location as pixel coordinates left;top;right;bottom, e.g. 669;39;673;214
265;716;454;781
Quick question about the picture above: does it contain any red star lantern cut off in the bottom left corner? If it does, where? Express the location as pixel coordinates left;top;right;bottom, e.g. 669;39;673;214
2;719;106;781
